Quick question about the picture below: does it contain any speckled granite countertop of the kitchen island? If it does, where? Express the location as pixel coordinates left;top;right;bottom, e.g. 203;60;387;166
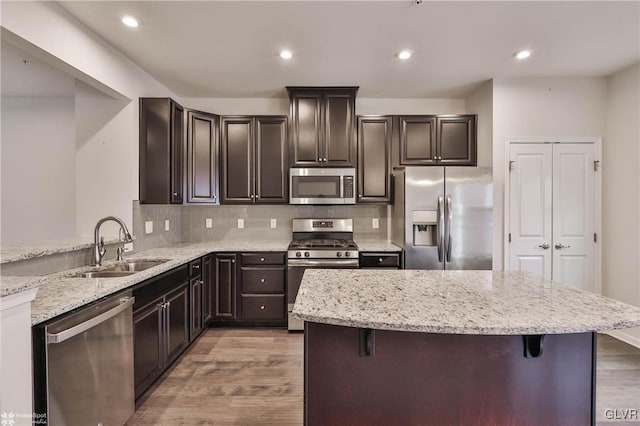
293;269;640;335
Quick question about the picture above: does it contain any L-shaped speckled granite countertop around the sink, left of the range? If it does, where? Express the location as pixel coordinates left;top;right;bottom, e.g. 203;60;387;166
8;240;289;325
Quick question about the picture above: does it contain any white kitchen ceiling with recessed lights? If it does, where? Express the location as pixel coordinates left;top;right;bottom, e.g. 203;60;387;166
59;0;640;98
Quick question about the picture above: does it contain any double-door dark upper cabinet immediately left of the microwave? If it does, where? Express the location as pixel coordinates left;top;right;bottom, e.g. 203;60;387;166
221;116;289;204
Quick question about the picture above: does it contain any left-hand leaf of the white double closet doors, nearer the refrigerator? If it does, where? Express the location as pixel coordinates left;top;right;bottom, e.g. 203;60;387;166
509;144;553;279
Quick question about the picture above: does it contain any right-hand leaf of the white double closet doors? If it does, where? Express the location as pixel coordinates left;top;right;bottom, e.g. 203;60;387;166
552;144;595;290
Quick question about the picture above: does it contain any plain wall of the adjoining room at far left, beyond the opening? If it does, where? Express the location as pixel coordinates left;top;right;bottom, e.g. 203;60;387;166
1;97;76;247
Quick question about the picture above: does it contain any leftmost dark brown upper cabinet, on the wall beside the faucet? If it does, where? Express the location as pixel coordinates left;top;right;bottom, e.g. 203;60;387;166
139;98;184;204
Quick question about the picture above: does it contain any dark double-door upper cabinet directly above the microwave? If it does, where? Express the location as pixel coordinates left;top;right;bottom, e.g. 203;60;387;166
287;87;358;167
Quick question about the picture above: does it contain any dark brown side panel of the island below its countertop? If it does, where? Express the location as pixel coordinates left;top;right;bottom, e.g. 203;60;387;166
304;322;595;426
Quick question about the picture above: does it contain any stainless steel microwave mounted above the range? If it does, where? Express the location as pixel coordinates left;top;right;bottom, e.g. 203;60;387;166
289;167;356;204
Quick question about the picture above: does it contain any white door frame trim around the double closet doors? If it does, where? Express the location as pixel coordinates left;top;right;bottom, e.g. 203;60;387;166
502;136;603;294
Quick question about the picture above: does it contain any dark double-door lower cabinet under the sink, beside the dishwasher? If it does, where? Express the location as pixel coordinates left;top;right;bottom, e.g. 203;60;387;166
133;265;190;399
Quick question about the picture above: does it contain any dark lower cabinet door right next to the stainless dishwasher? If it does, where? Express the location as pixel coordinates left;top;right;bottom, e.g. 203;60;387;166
133;297;164;399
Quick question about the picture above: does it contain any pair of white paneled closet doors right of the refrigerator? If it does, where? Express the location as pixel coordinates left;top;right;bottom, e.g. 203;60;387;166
508;143;595;290
